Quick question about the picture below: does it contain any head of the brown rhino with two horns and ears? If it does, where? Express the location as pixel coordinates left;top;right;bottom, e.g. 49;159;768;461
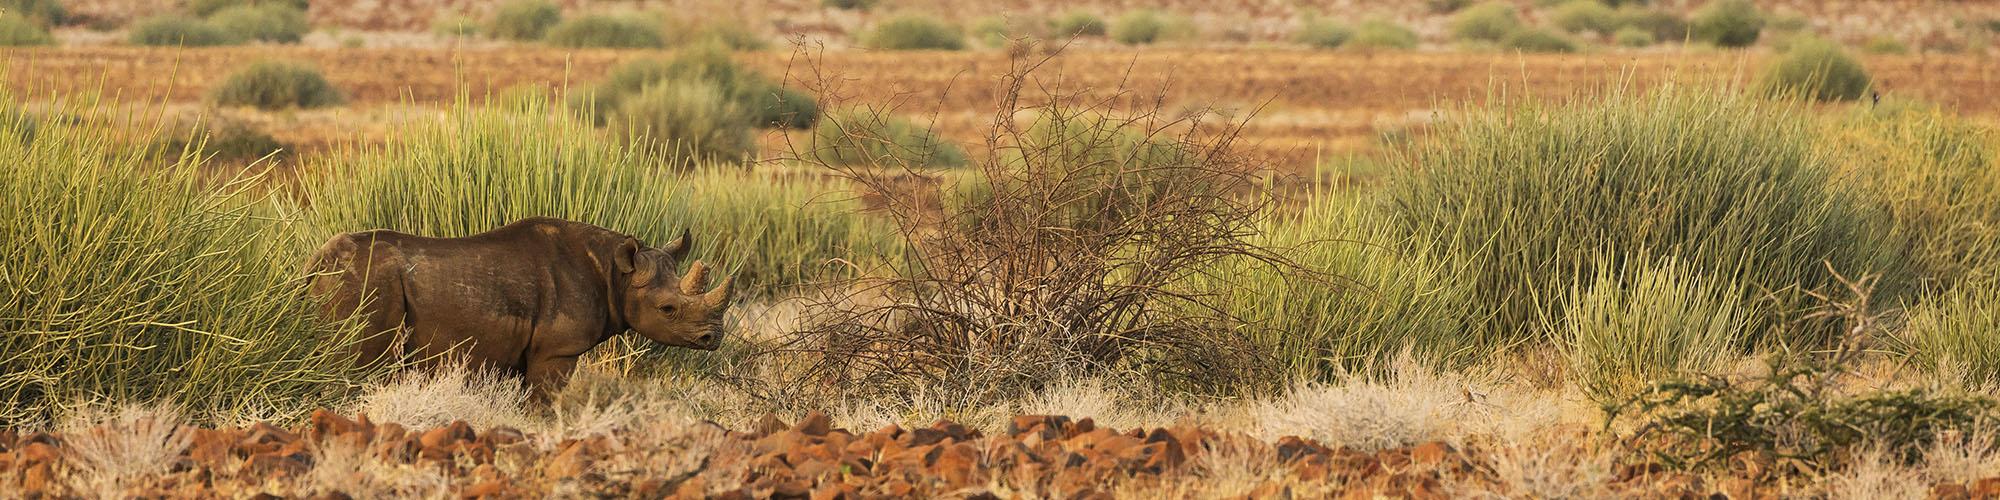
612;230;734;350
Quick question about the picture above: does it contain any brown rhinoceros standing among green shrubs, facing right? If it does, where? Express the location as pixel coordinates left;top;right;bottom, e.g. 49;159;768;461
308;218;732;400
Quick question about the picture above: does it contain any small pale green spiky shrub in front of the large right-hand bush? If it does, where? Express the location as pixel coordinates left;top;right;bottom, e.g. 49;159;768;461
1558;262;1744;402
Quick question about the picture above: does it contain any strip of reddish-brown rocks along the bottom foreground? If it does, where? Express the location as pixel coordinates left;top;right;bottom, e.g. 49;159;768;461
0;410;2000;498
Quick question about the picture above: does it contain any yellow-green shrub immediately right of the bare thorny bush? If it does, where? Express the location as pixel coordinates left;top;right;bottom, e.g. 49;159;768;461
1212;192;1502;376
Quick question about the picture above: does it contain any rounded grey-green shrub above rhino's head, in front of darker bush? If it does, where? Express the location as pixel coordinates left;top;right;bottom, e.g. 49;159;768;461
610;80;756;164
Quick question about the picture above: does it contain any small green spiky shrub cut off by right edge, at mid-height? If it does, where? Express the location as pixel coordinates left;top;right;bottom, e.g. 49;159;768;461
1900;280;2000;386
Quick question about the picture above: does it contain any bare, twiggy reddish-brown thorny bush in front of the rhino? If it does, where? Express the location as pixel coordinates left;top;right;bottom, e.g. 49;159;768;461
744;42;1310;410
